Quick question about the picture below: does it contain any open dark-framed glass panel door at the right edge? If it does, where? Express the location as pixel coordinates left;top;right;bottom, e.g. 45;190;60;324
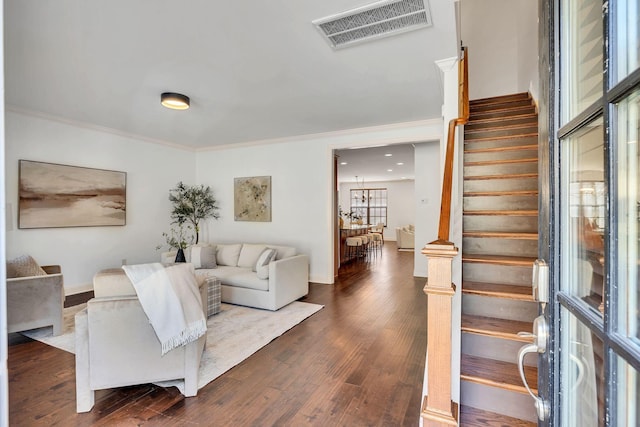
541;0;640;427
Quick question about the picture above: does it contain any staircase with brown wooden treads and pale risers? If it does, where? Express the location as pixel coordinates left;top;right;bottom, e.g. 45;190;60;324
460;93;538;426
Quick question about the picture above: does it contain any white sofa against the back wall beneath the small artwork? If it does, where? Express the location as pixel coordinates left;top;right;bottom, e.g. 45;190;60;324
161;243;309;311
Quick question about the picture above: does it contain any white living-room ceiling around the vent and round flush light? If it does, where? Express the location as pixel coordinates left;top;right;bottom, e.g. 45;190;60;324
4;0;456;149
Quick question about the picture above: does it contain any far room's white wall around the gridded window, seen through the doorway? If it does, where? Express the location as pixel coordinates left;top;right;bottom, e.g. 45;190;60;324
339;180;416;241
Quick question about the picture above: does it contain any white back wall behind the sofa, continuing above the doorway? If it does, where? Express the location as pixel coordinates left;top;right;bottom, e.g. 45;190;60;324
196;119;442;283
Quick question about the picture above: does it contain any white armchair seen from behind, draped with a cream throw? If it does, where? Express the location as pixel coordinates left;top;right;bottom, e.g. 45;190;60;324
75;269;207;412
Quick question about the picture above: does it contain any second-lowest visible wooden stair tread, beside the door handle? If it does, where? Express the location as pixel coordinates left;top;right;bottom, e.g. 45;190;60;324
460;354;538;394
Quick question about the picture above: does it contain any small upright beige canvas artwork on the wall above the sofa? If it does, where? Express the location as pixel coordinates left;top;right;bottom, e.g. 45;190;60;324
233;176;271;222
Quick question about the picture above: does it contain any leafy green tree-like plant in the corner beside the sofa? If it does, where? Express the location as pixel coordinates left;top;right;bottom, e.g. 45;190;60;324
169;182;220;244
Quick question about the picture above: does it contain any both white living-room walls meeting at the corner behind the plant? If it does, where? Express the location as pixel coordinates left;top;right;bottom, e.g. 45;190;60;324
5;111;442;294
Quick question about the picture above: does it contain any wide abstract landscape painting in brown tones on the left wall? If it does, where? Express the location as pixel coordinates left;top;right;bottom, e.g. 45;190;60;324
18;160;127;229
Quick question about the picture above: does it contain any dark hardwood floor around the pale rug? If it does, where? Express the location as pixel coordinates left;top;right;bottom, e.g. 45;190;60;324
9;242;426;426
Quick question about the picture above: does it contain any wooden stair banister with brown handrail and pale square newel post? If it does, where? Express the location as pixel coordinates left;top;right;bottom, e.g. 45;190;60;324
421;47;469;426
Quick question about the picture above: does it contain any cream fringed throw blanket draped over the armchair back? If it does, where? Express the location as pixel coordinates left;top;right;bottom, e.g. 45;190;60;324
122;263;207;355
